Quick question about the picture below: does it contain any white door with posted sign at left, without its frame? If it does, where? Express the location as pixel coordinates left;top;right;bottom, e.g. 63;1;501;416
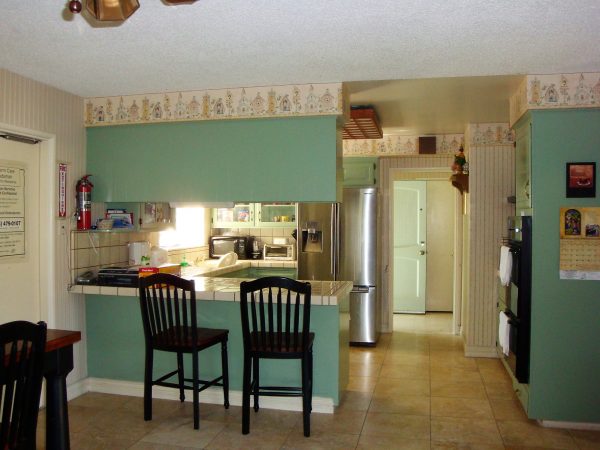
0;138;42;323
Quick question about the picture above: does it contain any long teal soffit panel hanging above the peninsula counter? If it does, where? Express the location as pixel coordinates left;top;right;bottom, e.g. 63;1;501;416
87;116;341;202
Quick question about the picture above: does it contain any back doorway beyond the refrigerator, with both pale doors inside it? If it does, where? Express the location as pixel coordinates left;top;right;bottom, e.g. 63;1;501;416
389;169;462;333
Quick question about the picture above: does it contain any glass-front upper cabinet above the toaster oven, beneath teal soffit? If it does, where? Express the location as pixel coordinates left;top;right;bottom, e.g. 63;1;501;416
212;202;296;228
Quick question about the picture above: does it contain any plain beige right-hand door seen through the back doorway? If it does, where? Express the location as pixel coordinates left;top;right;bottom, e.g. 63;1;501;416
426;180;456;312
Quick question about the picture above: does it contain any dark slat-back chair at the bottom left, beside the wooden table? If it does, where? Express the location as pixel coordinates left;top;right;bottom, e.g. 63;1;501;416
0;321;46;450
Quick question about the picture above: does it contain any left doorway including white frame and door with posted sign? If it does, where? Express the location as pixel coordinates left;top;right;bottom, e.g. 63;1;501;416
0;124;56;327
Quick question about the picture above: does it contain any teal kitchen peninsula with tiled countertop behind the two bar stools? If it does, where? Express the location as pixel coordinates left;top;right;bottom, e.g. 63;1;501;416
79;272;352;413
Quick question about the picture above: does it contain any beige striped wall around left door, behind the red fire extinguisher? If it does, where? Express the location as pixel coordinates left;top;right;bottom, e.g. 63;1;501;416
0;69;87;384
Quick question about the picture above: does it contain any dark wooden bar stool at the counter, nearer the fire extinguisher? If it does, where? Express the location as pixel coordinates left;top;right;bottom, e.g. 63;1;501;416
139;273;229;429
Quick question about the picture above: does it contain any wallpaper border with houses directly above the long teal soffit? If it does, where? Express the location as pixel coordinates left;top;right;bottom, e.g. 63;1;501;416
84;83;345;127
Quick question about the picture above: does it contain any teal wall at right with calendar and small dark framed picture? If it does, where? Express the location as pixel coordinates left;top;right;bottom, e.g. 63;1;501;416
529;109;600;422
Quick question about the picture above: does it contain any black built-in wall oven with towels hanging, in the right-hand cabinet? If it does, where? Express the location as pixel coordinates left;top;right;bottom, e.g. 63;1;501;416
505;216;531;383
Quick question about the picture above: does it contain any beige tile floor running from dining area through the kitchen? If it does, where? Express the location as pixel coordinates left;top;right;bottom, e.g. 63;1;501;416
38;314;600;450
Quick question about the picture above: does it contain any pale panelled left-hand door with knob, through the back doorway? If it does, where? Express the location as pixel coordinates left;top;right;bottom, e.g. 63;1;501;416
393;181;427;314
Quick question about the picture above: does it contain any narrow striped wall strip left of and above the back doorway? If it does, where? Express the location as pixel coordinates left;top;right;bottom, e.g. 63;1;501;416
378;155;454;333
